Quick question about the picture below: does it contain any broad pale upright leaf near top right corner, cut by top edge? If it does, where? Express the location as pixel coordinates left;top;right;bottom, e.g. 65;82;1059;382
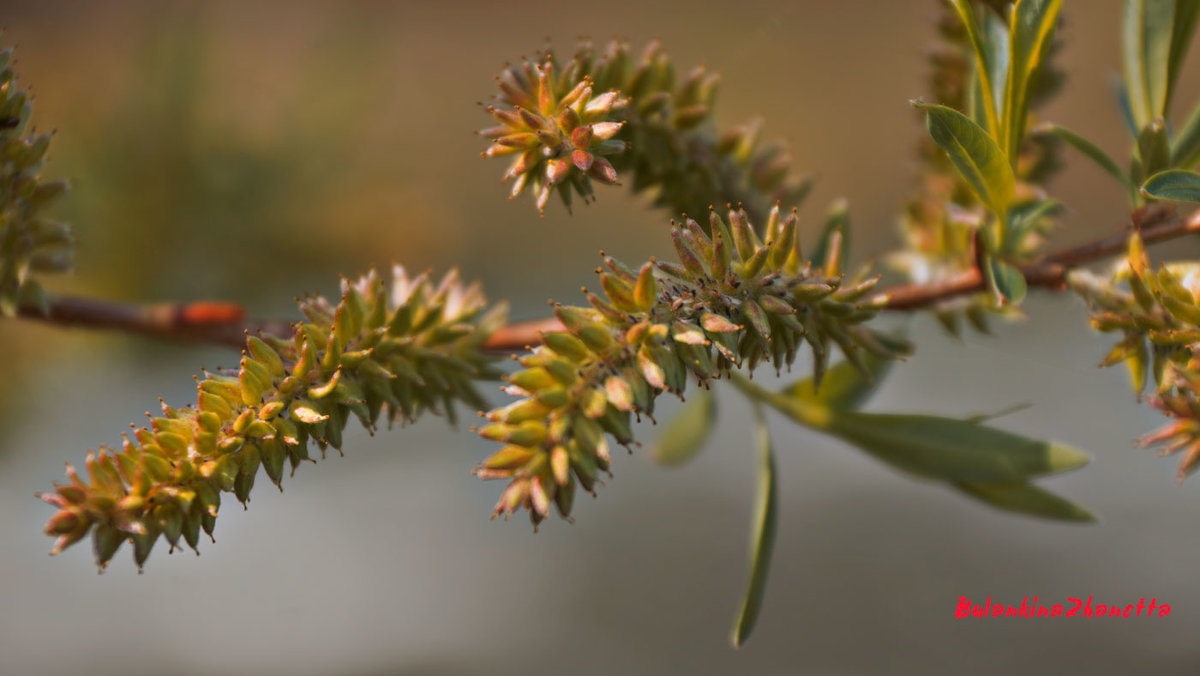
1121;0;1187;128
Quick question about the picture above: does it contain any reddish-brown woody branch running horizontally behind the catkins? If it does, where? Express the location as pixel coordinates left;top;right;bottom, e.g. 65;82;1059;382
19;205;1200;352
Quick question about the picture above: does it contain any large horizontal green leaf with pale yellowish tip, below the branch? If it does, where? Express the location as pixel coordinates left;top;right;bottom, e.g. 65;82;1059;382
829;411;1088;484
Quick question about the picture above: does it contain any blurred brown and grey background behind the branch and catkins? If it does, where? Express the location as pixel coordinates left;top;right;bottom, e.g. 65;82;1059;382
7;0;1200;675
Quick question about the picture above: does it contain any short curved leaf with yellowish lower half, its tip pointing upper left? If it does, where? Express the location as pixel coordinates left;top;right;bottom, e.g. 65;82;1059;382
913;101;1016;214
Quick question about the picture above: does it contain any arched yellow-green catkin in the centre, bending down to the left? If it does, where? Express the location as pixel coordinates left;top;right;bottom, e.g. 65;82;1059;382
475;207;907;525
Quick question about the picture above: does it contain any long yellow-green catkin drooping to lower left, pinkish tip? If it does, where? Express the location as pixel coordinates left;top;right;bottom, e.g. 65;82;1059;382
40;267;504;568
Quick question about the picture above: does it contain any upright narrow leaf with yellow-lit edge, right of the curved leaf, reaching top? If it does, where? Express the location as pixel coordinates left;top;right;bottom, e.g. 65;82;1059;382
1003;0;1062;159
